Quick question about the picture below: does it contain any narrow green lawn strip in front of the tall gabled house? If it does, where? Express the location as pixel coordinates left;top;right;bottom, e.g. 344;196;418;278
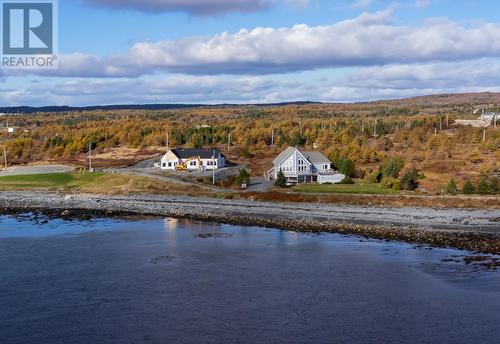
292;182;400;195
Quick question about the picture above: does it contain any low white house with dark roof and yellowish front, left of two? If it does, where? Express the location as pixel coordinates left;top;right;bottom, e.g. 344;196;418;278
160;148;225;171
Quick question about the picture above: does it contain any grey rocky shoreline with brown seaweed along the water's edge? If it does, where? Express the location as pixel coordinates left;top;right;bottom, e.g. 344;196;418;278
0;192;500;254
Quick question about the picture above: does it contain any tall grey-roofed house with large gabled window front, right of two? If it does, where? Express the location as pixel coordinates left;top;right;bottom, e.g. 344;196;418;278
268;147;345;184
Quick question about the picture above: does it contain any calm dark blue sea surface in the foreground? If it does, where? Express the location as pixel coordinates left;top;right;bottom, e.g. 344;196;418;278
0;214;500;344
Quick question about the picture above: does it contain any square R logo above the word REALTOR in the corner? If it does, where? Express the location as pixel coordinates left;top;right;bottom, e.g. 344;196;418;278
2;1;54;55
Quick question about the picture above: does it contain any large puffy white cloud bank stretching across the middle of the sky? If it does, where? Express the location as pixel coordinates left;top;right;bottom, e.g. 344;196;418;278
29;10;500;77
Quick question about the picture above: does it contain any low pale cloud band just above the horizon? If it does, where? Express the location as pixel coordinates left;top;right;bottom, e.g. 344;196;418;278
4;59;500;105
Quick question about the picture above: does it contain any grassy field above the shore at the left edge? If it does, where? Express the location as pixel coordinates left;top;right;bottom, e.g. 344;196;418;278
0;173;215;195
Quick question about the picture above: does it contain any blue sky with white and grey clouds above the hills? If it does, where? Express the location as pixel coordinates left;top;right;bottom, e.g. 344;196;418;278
0;0;500;106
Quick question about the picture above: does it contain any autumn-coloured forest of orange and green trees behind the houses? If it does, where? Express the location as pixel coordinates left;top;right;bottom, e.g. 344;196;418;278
0;102;500;194
